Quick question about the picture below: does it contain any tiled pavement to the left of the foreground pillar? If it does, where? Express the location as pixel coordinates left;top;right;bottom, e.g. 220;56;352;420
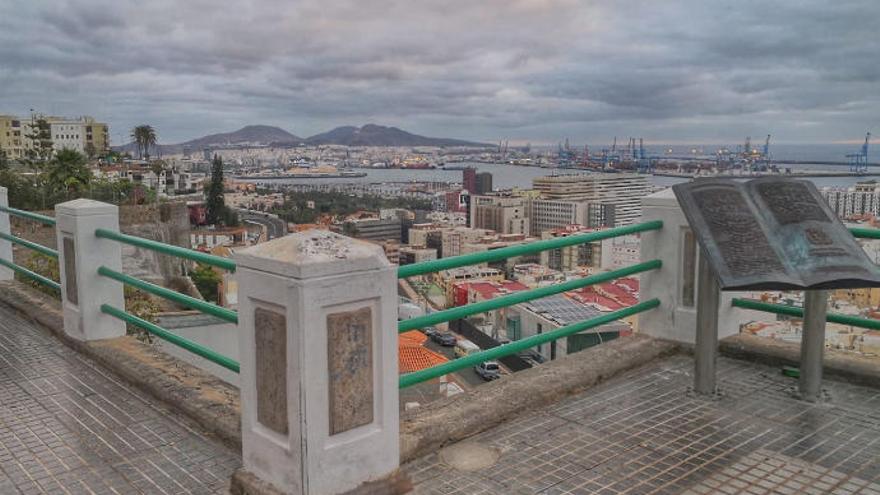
0;306;241;495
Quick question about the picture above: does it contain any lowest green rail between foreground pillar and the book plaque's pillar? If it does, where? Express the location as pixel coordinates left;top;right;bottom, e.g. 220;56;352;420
399;299;660;388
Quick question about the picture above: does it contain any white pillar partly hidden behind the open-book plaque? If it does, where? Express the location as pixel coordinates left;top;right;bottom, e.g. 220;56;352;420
639;189;773;345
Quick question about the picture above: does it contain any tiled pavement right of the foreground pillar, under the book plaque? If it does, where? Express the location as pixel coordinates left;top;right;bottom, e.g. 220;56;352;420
404;357;880;495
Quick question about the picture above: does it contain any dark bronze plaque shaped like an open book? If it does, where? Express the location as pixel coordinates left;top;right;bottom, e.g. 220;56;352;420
672;177;880;290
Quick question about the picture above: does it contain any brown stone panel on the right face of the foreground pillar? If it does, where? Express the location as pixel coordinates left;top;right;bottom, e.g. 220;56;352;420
327;308;373;435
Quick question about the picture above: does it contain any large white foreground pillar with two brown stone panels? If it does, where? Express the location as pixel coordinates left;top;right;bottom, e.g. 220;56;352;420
235;230;400;495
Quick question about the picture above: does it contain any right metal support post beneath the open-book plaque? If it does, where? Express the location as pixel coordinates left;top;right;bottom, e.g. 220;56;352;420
798;290;828;402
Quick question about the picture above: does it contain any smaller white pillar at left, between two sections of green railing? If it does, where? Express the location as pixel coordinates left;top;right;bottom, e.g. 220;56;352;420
55;199;125;340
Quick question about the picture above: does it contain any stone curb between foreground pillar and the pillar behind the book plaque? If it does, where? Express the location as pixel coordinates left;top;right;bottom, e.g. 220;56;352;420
400;334;679;463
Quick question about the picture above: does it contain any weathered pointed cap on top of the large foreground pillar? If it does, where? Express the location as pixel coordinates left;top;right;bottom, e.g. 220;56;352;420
233;229;391;278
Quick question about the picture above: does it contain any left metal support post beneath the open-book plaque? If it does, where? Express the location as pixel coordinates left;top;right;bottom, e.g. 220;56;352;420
694;252;721;395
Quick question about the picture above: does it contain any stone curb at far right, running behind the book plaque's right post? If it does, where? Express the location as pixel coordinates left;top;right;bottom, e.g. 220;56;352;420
719;334;880;388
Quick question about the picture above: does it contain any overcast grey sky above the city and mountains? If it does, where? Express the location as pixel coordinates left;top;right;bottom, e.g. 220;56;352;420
0;0;880;144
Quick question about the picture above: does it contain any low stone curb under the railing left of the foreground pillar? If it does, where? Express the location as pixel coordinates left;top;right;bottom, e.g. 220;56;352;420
0;282;241;451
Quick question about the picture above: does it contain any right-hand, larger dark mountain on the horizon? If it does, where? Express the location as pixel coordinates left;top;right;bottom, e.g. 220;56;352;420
305;124;492;147
